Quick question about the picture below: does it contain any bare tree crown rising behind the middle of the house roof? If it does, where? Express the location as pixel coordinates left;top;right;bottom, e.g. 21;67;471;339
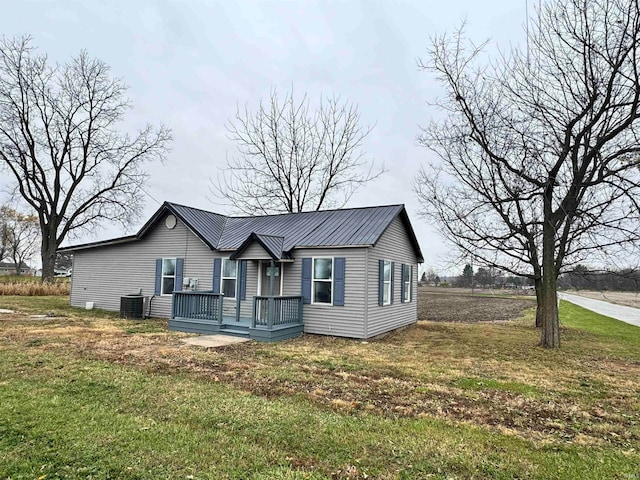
211;91;384;215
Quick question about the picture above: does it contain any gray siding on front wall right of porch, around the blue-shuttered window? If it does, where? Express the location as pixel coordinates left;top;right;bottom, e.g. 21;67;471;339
283;247;367;338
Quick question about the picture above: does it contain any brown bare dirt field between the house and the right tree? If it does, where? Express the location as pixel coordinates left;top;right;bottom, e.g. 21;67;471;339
418;291;535;323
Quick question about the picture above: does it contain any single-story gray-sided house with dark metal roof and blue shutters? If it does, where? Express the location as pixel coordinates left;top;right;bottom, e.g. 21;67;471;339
59;202;423;341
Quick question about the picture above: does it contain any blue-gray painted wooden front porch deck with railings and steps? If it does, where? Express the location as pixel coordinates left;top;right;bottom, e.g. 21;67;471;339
169;291;304;342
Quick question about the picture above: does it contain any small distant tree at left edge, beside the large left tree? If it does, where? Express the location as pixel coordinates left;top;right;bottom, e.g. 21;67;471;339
0;206;40;275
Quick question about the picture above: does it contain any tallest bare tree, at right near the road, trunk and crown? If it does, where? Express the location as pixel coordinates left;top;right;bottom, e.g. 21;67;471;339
415;0;640;347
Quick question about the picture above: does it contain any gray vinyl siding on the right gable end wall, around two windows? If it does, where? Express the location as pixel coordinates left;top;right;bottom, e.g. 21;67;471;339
366;217;418;338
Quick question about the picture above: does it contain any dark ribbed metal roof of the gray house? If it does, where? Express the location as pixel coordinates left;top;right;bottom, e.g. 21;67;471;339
60;202;423;262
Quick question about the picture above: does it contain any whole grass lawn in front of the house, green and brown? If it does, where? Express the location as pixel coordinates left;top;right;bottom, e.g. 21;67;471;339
0;297;640;479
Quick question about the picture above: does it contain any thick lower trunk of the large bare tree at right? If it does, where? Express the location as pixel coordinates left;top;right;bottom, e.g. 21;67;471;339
540;219;560;348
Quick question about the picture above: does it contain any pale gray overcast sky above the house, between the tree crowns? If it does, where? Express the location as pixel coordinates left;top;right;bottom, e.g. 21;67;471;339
0;0;531;274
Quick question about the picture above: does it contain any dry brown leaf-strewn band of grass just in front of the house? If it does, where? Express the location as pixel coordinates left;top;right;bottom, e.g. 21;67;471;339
0;296;640;449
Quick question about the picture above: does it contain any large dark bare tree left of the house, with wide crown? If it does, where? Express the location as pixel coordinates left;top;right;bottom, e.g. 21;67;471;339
0;37;171;281
